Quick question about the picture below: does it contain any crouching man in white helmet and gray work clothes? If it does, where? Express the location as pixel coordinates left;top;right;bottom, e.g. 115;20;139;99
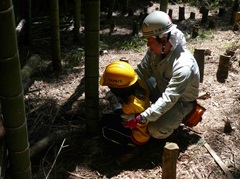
124;11;199;139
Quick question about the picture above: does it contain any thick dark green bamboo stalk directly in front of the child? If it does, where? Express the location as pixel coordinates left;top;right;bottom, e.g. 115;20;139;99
85;0;100;133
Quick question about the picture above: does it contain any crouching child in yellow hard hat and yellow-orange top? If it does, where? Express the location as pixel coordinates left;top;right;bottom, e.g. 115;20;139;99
100;60;150;150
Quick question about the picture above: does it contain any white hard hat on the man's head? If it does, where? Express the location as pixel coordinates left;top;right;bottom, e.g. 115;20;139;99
142;11;176;38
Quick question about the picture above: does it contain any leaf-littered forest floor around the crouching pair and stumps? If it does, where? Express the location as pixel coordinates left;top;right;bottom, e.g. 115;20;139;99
19;1;240;179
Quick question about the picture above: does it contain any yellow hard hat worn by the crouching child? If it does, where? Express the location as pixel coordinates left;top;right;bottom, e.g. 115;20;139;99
100;60;138;88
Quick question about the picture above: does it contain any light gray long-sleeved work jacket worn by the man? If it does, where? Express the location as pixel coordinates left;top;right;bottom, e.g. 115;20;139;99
136;45;200;121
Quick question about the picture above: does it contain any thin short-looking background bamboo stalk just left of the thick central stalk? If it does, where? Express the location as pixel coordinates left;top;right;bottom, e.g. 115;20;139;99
73;0;81;42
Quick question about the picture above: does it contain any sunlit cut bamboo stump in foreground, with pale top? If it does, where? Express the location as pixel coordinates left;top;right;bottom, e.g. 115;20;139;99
162;142;179;179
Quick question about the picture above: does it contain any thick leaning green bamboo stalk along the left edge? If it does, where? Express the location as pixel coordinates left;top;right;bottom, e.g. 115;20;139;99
0;0;31;179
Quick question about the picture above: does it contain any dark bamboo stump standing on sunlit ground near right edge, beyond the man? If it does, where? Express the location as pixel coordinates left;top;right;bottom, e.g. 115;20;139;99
217;55;231;83
